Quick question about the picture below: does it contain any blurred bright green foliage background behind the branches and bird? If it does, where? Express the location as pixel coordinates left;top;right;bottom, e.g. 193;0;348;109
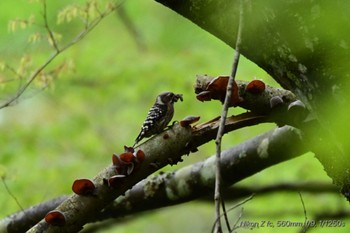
0;0;350;233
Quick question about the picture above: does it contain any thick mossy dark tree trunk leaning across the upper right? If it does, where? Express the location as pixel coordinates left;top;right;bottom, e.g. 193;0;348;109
156;0;350;200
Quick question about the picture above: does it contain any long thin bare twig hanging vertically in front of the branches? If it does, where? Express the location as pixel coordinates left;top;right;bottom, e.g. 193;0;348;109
214;1;243;233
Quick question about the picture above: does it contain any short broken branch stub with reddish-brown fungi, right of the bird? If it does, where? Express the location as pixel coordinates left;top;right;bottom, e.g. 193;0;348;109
194;75;308;127
